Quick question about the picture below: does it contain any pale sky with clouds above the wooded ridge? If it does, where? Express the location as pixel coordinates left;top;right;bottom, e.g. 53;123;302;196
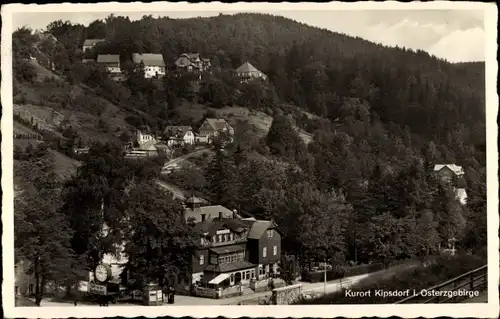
13;9;486;62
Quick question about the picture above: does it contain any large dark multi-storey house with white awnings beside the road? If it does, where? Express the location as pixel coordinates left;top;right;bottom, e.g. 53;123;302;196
186;205;282;296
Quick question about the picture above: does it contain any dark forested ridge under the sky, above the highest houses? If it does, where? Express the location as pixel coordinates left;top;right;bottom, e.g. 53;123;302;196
48;13;485;151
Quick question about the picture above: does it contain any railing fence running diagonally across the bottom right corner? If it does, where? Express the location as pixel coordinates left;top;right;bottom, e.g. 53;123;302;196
396;265;488;304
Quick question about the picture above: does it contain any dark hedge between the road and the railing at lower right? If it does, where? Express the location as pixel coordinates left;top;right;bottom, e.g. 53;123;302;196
298;255;486;304
